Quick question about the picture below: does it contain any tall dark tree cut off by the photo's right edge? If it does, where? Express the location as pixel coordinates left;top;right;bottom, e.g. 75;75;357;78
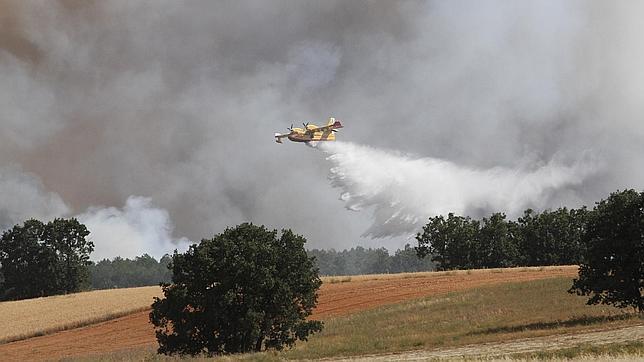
569;190;644;312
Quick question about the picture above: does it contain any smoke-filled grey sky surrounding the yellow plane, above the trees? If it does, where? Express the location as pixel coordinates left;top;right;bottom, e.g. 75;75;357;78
0;0;644;256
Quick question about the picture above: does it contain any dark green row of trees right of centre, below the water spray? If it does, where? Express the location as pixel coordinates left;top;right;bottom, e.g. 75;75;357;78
416;207;590;270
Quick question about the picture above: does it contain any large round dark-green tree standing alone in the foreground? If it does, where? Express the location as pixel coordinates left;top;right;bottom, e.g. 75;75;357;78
150;223;322;355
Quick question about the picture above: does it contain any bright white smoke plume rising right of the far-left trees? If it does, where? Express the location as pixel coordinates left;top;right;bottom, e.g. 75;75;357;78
77;196;189;260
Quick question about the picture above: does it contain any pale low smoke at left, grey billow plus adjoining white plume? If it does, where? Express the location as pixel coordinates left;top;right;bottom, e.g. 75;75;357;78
0;166;190;260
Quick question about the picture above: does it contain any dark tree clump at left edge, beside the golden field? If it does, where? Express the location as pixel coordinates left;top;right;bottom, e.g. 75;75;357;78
0;219;94;300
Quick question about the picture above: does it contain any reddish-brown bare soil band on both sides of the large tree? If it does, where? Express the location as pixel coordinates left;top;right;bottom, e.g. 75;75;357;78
0;266;577;361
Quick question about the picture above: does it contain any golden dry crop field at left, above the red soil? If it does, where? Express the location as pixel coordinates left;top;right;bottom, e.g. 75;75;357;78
0;286;161;343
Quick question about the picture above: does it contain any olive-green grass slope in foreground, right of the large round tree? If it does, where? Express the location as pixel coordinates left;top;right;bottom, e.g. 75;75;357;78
68;278;643;361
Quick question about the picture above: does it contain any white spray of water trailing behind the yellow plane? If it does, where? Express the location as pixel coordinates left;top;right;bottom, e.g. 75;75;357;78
318;142;598;238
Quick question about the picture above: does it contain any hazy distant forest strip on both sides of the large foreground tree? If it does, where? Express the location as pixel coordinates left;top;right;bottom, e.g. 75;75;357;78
84;244;434;289
